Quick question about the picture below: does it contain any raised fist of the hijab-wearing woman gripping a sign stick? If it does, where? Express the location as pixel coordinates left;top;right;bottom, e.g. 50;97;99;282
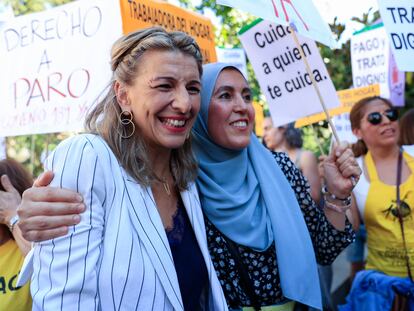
323;142;362;198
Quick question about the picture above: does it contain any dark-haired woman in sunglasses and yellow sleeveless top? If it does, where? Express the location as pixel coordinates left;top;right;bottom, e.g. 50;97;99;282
344;97;414;310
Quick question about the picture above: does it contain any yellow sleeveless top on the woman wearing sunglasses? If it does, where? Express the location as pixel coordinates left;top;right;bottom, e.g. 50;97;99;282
364;152;414;277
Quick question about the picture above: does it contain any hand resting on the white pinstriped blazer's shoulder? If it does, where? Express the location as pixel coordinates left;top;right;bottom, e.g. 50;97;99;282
17;172;85;241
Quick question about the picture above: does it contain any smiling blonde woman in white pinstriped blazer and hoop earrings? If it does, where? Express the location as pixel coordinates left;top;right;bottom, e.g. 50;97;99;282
18;27;227;311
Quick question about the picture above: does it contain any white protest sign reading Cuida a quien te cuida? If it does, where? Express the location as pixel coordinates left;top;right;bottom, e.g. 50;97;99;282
239;20;339;126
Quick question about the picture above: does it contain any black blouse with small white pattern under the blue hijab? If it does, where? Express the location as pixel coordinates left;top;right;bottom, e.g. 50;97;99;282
205;152;355;308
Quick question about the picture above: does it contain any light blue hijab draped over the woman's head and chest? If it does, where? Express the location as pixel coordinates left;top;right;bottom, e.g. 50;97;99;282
193;63;321;309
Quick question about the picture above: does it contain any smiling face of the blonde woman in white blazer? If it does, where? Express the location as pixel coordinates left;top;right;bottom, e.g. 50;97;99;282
117;51;201;154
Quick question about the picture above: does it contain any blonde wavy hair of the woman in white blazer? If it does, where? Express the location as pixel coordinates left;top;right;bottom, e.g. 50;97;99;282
85;27;202;191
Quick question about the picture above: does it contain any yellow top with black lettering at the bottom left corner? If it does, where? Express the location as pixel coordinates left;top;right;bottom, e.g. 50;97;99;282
0;239;32;311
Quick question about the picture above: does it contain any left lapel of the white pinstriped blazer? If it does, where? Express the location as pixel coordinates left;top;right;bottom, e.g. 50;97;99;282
124;176;184;310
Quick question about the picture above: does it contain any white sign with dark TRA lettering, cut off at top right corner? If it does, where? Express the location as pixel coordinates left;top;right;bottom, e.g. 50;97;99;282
378;0;414;71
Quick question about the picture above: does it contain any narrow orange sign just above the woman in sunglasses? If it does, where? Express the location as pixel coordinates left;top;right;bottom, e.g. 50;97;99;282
295;84;380;127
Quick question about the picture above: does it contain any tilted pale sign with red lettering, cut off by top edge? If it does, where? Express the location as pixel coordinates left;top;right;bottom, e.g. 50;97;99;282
217;0;337;48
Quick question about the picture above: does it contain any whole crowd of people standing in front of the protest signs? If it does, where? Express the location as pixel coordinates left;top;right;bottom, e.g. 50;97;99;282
0;27;414;311
